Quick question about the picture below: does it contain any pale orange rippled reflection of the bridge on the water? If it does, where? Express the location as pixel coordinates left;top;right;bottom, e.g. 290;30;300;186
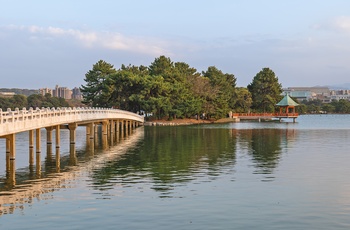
0;126;144;216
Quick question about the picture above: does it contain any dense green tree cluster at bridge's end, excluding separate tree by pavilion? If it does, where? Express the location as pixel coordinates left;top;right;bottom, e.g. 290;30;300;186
81;56;236;119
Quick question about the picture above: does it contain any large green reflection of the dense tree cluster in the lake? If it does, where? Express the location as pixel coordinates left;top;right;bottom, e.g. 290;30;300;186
92;126;236;196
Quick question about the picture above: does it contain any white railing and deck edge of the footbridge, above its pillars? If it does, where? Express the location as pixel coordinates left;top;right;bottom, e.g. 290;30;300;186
0;108;144;136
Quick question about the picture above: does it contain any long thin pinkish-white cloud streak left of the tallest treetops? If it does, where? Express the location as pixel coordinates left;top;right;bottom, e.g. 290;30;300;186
5;25;171;56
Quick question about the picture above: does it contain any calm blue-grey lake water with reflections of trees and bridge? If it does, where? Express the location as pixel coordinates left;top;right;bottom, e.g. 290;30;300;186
0;115;350;230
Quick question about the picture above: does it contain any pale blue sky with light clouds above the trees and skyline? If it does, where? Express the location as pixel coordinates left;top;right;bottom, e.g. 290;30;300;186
0;0;350;89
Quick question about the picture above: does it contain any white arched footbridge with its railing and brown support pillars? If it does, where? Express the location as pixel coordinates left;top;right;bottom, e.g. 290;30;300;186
0;108;144;181
